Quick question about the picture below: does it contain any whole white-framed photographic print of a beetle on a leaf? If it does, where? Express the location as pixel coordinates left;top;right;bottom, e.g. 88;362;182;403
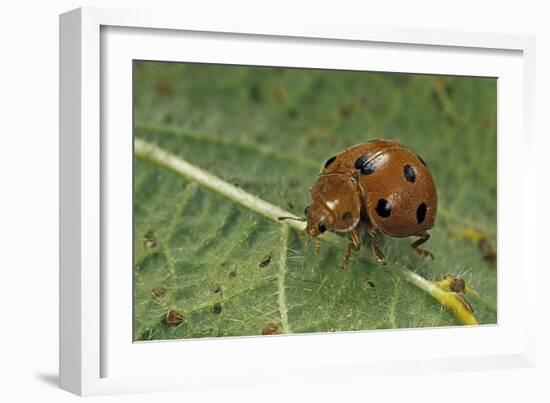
60;8;536;394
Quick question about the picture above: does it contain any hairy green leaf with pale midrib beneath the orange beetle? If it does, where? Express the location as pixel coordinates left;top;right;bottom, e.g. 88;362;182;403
134;62;496;340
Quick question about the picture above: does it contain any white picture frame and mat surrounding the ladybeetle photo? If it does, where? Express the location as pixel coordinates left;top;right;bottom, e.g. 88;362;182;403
60;8;537;395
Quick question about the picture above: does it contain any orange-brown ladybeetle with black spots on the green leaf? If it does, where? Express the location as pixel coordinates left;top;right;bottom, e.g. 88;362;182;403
280;140;437;268
